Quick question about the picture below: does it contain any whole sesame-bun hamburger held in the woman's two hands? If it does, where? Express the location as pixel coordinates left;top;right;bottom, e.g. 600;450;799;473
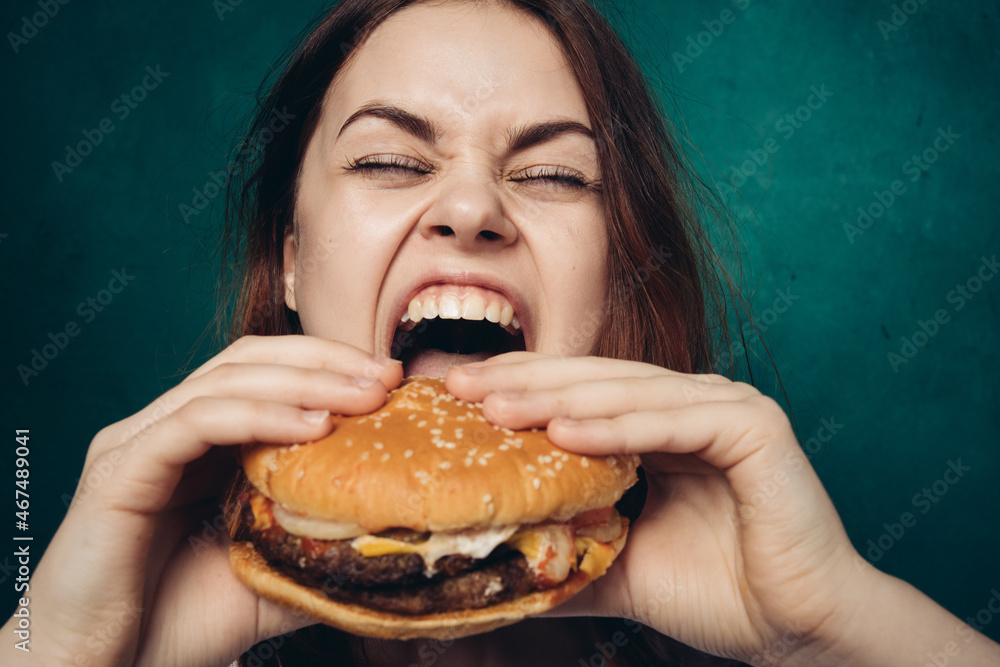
230;378;638;639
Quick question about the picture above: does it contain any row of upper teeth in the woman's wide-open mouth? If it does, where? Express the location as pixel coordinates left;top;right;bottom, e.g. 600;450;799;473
400;285;521;335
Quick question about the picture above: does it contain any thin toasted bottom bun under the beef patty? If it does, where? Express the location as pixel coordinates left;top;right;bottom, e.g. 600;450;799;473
229;530;628;640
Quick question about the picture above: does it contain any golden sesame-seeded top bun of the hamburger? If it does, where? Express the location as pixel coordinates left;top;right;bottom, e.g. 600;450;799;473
242;377;639;532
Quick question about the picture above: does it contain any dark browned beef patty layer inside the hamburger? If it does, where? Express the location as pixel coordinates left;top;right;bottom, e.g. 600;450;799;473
241;490;535;614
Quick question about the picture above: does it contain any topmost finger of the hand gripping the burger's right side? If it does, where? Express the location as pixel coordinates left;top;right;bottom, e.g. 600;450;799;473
447;357;688;401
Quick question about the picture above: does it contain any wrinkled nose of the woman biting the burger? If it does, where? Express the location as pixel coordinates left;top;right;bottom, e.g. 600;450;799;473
419;179;517;251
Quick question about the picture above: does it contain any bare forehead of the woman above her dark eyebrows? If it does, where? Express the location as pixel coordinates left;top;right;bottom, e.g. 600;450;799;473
324;1;590;137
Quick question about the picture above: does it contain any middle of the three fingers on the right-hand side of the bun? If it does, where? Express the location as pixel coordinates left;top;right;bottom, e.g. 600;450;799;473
483;374;760;430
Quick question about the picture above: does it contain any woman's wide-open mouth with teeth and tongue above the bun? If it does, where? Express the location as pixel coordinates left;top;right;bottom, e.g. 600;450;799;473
392;285;525;376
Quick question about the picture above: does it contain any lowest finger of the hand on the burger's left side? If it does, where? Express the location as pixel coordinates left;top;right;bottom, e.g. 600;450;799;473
88;396;332;514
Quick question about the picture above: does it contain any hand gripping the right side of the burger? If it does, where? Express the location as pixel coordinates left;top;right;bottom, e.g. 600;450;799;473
447;352;868;663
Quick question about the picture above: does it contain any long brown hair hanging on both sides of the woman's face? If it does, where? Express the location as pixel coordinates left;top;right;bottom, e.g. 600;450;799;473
219;0;748;665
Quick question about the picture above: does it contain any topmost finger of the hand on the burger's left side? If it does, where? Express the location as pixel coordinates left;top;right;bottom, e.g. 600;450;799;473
185;335;403;389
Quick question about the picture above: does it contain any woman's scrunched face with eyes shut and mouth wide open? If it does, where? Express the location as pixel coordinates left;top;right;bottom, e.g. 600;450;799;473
285;2;607;375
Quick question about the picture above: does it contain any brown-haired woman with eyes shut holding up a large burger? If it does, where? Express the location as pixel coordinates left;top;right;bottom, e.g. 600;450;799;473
0;0;1000;665
